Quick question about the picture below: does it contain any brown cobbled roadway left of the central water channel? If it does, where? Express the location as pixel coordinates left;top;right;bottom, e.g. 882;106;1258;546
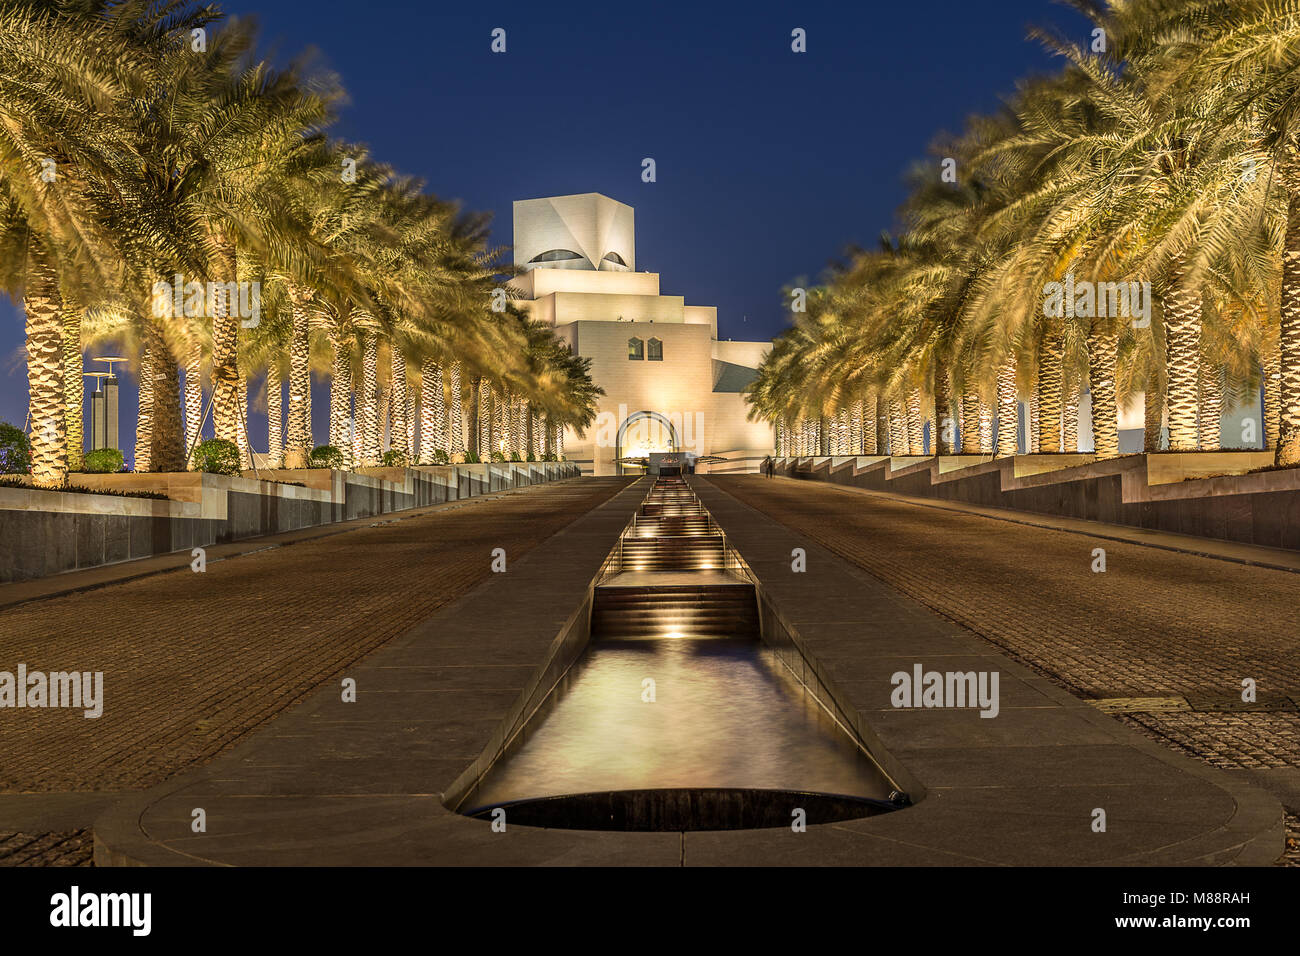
0;479;628;864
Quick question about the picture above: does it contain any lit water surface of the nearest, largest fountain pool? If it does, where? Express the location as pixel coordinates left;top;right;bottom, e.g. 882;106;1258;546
467;637;892;806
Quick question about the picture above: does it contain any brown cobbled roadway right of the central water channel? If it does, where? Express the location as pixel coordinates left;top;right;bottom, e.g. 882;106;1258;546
715;476;1300;858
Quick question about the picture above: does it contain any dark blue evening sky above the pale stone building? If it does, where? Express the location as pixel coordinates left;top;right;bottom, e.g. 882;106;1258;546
0;0;1088;451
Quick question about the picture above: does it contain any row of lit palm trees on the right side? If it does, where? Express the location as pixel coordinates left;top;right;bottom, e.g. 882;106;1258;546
750;0;1300;466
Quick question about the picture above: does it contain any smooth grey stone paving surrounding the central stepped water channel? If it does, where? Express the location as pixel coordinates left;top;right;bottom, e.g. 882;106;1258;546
95;481;1282;866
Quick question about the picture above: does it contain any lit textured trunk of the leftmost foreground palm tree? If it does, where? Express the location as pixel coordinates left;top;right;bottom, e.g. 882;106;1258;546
22;237;68;488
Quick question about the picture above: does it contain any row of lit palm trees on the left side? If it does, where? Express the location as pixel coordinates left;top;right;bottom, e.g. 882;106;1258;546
0;0;597;485
